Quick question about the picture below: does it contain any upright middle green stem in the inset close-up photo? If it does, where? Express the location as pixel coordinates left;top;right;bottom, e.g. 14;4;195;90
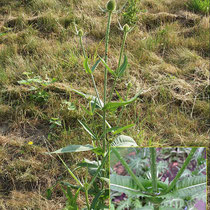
149;147;157;193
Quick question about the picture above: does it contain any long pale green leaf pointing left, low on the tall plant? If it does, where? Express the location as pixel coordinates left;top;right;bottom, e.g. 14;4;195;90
47;144;94;154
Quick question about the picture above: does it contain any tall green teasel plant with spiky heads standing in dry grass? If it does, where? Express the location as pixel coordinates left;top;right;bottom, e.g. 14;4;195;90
46;0;140;209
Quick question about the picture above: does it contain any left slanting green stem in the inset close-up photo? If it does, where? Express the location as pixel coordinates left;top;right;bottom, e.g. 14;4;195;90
112;147;146;191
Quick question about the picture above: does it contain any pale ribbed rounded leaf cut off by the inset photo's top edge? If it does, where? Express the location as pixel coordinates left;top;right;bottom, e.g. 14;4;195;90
111;135;138;147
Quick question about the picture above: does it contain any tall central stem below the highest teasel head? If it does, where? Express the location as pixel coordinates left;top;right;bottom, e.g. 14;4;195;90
103;11;112;153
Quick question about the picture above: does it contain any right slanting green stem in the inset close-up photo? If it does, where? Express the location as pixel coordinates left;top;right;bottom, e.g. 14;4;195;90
164;147;197;194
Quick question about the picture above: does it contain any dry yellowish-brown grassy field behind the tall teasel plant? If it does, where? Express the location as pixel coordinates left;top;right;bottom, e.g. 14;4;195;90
0;0;210;209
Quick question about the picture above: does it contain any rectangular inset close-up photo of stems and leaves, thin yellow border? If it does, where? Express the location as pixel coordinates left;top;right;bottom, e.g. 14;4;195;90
110;147;207;210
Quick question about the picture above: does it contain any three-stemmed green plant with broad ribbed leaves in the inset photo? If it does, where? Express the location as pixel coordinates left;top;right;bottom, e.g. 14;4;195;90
110;148;206;210
